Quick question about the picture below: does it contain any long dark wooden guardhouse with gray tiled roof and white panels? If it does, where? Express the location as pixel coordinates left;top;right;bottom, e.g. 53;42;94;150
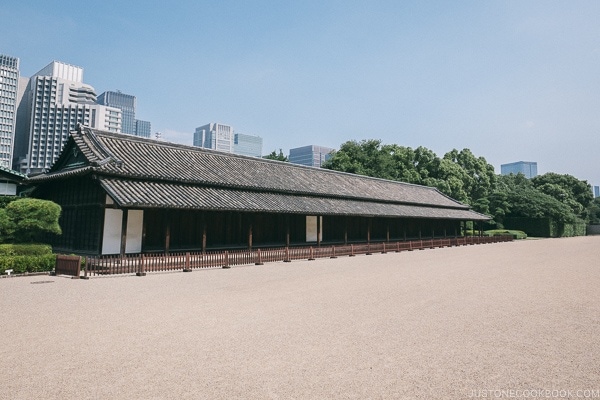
29;127;489;255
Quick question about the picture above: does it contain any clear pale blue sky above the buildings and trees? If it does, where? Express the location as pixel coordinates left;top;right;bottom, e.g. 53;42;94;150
0;0;600;185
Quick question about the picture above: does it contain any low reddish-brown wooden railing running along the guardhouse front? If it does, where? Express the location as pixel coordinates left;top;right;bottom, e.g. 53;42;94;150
84;236;513;277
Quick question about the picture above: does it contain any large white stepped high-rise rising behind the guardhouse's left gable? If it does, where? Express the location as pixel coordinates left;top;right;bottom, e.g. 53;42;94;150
13;61;122;174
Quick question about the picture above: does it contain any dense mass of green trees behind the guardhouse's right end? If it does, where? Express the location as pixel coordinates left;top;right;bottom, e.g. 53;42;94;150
323;139;600;225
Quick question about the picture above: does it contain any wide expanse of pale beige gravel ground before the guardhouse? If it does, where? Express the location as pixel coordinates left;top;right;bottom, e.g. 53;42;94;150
0;236;600;399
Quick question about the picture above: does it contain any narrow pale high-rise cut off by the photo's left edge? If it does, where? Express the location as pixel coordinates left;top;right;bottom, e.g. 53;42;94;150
0;54;19;168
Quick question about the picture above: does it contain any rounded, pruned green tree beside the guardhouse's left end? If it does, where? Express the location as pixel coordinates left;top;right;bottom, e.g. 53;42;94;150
5;198;62;243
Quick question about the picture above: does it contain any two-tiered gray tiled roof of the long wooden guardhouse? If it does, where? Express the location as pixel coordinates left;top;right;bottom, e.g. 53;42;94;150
31;128;489;220
